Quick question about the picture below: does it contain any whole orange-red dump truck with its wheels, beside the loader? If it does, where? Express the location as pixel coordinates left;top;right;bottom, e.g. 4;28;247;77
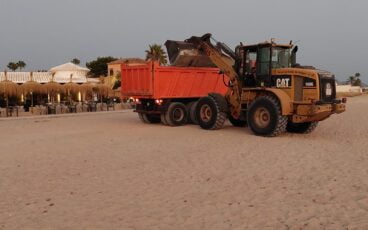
121;61;228;126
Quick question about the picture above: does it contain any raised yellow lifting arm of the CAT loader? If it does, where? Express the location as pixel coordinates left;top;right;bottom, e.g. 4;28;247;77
185;34;242;119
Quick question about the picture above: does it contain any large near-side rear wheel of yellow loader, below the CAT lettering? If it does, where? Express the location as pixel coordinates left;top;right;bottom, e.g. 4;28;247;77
247;96;287;137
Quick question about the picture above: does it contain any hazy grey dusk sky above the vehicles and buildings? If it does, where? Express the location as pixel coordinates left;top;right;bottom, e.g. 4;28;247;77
0;0;368;83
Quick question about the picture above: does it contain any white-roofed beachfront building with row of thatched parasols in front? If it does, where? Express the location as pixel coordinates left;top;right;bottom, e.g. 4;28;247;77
0;62;103;110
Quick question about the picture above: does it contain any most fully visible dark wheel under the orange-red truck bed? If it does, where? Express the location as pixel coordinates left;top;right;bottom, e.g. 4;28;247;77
165;102;187;126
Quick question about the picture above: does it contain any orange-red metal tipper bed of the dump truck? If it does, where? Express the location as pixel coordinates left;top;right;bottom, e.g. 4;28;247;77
121;62;228;99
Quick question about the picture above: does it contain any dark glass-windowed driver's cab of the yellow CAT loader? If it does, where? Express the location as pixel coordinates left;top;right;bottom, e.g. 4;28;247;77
239;42;297;87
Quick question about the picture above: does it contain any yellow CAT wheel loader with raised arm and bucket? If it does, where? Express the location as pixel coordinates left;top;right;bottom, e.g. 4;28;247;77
168;34;346;136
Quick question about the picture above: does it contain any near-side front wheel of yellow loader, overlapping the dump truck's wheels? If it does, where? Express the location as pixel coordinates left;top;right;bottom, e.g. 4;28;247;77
196;96;227;130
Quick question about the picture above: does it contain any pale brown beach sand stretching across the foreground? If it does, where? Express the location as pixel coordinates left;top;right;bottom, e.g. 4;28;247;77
0;96;368;230
